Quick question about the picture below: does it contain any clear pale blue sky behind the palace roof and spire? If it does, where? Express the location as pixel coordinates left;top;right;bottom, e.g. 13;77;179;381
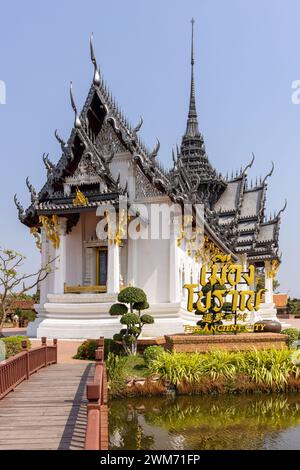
0;0;300;296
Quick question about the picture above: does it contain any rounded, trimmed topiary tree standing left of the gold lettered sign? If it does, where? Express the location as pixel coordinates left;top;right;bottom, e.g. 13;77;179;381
109;287;154;355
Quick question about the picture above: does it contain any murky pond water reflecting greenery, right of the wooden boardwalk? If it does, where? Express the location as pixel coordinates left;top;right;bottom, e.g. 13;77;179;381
109;394;300;450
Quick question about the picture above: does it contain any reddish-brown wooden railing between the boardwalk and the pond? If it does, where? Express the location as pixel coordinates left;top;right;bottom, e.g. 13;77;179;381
85;337;108;450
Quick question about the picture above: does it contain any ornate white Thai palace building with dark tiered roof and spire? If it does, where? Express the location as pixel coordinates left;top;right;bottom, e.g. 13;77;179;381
15;22;285;338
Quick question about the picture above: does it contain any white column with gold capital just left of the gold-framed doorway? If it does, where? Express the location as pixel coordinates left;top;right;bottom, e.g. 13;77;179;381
53;217;67;294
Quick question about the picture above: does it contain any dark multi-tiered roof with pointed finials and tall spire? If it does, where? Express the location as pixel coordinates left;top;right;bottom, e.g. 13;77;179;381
15;20;286;265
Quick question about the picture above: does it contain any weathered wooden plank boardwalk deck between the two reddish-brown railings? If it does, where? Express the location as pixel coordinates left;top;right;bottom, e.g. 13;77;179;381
0;362;94;450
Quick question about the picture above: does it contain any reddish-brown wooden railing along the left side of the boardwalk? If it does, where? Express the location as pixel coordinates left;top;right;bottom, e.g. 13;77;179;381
0;338;57;400
